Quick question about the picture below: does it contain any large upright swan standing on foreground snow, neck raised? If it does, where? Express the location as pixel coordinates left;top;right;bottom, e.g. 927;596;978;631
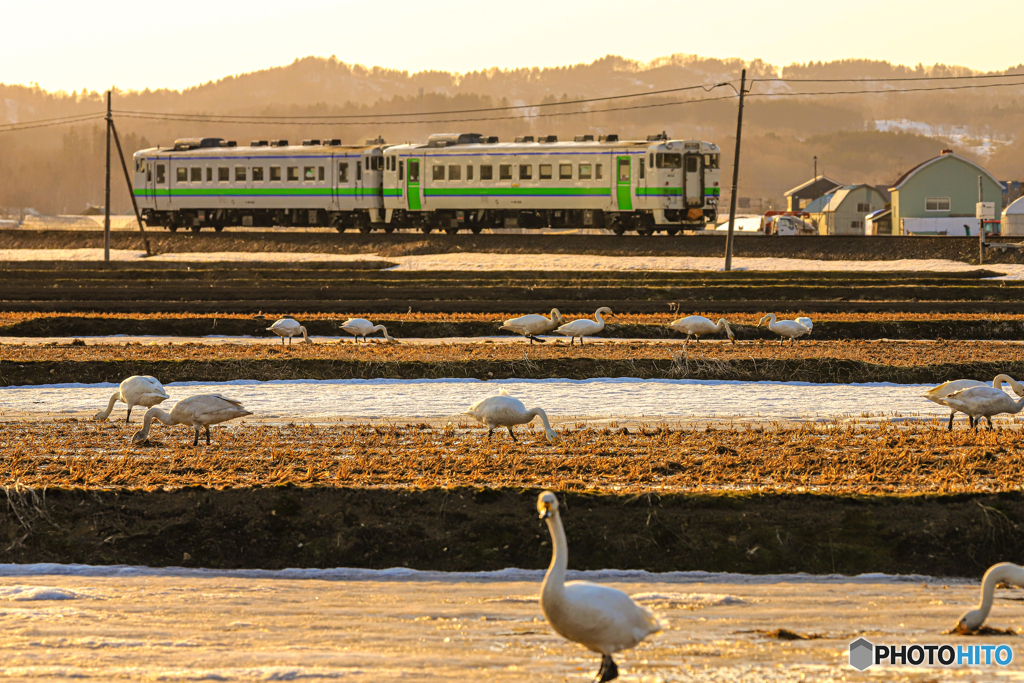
537;490;662;683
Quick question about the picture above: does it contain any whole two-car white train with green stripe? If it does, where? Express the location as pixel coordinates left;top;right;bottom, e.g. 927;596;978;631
133;133;721;234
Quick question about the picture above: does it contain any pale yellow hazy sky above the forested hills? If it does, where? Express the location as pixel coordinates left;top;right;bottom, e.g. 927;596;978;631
6;0;1024;92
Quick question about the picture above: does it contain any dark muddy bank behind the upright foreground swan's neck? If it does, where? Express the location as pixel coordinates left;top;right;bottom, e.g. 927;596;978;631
0;486;1024;575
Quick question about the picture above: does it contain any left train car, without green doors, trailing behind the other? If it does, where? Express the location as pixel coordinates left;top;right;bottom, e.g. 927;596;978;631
134;137;385;232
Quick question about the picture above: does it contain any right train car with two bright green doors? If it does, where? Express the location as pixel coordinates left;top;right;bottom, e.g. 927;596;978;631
383;133;720;234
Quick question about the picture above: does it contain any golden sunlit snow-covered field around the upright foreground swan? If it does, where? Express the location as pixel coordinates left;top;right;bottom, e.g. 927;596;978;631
0;565;1007;683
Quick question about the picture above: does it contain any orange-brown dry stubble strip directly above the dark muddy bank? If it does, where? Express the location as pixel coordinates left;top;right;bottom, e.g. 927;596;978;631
0;420;1024;495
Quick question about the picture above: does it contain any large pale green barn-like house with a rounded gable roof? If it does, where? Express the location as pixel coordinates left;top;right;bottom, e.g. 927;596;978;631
889;150;1002;234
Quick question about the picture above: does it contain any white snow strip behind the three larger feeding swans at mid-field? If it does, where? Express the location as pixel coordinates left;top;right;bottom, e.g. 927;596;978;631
0;378;991;424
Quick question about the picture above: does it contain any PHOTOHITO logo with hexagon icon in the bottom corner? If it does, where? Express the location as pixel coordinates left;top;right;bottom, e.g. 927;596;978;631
850;638;1014;671
